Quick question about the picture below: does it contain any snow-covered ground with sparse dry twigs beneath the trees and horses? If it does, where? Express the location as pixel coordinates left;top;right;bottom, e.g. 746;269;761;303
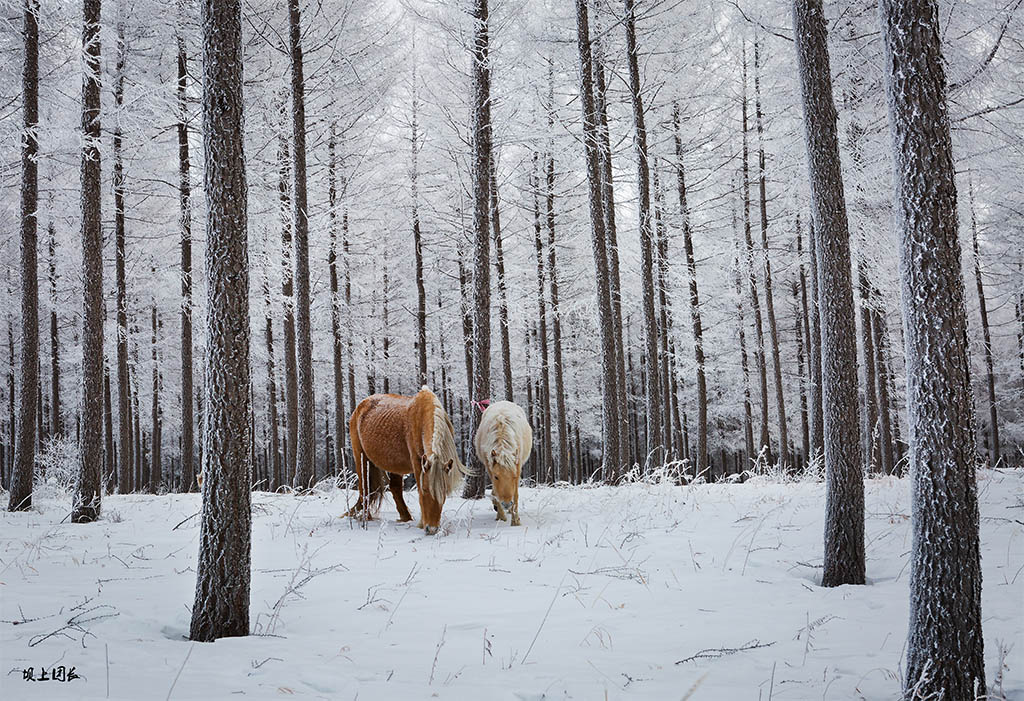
0;464;1024;700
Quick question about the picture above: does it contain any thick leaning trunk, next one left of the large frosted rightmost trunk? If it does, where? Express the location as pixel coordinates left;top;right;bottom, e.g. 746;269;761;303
794;0;864;586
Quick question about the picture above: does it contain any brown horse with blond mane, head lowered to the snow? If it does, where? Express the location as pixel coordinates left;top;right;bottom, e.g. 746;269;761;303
345;386;467;535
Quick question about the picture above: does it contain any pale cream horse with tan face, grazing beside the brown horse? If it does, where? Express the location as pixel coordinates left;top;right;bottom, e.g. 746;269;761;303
473;401;534;526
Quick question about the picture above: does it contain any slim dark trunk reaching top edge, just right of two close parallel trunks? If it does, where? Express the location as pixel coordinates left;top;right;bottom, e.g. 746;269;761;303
625;0;667;463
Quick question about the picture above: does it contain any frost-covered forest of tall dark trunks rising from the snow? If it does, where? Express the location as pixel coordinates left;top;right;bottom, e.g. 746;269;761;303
0;0;1024;699
